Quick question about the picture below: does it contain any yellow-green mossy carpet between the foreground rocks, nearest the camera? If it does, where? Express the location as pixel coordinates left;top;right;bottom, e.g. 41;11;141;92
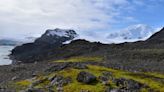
11;65;164;92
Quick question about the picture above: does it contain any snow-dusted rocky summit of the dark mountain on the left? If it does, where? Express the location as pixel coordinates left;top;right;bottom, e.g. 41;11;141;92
35;28;78;45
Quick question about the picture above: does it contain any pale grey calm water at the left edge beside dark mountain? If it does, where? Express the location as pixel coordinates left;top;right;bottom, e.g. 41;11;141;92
0;46;14;65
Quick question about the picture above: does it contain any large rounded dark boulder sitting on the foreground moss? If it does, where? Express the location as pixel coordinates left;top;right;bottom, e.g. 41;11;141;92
77;71;96;84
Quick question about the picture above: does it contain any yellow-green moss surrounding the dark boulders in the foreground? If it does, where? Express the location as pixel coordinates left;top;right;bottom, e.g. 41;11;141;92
9;65;164;92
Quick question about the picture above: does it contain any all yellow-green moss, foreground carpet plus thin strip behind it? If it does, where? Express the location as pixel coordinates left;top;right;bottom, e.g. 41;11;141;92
7;57;164;92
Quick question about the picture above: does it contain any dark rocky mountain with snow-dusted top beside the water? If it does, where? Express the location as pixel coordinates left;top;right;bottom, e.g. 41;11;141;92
10;29;78;63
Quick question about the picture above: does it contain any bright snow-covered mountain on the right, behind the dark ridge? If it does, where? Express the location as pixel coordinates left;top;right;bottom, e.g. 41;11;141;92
107;24;156;43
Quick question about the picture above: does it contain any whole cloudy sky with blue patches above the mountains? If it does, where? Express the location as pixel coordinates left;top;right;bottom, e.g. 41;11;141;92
0;0;164;39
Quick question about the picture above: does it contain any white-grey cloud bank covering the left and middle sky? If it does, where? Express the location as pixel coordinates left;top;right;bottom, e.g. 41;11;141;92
0;0;133;37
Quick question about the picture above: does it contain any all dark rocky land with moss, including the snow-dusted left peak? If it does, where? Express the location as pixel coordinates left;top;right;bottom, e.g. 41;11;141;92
0;28;164;92
